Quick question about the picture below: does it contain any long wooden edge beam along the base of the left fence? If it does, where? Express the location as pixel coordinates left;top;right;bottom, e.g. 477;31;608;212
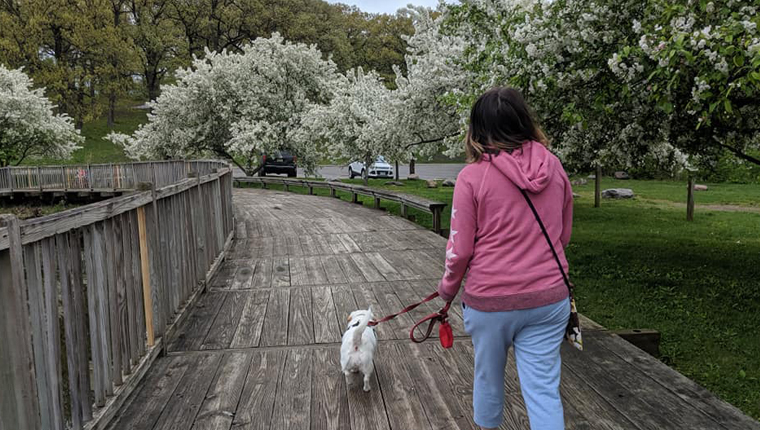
84;229;234;430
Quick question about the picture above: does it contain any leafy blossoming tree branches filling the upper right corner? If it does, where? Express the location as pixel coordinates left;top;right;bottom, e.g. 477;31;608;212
610;0;760;171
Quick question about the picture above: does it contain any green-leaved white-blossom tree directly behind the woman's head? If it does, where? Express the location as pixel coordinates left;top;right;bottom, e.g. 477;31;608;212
446;0;685;182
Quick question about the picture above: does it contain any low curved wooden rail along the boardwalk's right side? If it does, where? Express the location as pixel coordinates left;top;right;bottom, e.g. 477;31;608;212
234;176;446;234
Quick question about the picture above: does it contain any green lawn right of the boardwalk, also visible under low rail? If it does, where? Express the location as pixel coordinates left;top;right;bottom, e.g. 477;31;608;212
240;180;760;419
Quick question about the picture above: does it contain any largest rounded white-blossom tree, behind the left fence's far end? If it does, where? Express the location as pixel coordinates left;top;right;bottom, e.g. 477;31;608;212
108;33;345;174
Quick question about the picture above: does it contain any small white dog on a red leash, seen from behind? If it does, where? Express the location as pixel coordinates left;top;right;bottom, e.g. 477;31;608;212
340;308;377;391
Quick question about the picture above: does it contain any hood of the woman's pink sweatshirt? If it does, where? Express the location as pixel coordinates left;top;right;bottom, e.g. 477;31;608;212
488;141;559;194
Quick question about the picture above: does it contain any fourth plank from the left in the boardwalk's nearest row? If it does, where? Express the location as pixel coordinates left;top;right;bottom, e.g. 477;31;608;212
232;351;285;430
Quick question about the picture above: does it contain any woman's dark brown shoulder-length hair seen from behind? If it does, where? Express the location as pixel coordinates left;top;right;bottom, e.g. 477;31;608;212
465;87;548;163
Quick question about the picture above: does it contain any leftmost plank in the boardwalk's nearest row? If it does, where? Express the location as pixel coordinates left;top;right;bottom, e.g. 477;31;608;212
112;355;198;430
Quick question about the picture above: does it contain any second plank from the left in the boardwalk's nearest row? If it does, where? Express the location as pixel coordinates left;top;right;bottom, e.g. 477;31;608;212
153;354;223;430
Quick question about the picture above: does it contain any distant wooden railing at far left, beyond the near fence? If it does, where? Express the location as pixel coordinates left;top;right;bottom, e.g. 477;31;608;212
0;160;224;193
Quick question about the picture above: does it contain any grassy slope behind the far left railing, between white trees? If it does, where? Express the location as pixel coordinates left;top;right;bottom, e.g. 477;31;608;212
24;100;147;165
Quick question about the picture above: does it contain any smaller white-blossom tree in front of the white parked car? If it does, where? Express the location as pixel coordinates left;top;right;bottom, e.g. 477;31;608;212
299;68;398;184
